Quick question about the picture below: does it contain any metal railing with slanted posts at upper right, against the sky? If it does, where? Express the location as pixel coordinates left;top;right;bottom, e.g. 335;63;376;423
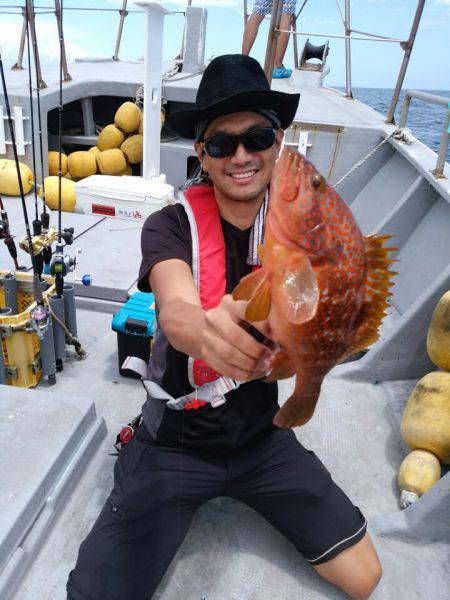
260;0;425;123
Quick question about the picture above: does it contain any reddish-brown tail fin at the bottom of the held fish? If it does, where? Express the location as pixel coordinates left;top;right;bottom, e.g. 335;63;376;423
273;375;322;428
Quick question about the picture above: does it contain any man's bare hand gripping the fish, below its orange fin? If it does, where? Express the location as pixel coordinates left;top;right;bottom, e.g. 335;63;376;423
201;295;274;381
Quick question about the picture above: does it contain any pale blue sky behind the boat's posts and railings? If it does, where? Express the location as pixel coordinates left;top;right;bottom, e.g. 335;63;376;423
0;0;450;90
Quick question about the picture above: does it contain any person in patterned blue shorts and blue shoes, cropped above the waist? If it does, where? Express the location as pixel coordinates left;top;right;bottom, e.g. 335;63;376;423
242;0;296;79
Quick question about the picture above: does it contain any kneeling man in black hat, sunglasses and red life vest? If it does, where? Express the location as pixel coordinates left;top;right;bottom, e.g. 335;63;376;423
68;55;381;600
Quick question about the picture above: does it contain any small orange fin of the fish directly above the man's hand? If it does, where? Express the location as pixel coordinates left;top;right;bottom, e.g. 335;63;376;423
233;268;270;322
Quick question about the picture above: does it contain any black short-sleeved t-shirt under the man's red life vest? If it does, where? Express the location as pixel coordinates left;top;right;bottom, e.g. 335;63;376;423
138;199;278;452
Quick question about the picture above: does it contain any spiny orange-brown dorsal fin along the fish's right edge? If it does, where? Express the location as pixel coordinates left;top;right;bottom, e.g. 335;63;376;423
342;235;397;360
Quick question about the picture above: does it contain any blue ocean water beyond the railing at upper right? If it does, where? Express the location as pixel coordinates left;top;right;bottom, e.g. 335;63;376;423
340;88;450;163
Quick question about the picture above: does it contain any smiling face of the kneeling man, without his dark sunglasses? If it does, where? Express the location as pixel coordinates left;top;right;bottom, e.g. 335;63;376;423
195;112;284;202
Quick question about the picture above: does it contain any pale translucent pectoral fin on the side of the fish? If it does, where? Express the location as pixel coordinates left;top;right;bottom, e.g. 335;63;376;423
278;254;320;325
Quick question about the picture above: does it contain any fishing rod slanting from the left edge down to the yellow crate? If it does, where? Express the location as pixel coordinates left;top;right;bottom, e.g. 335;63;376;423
0;51;48;336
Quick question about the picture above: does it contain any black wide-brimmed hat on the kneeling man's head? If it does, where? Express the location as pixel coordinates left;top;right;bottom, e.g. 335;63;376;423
166;54;300;139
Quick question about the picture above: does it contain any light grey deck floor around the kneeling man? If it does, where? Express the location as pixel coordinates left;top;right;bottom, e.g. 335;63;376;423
9;300;448;600
